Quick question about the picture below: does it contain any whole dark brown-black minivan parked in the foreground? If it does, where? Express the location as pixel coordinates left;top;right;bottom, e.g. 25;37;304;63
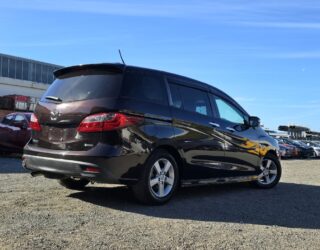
23;64;281;204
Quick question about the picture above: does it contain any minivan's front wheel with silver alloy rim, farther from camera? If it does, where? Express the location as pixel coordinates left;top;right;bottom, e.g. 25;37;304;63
253;154;282;189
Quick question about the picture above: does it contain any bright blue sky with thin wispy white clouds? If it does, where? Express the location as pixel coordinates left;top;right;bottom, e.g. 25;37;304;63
0;0;320;131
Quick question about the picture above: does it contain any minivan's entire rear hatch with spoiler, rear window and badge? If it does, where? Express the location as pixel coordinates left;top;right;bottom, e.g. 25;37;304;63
33;64;123;151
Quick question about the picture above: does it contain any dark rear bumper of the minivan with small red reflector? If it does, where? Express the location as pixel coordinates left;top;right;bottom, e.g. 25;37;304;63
23;145;145;185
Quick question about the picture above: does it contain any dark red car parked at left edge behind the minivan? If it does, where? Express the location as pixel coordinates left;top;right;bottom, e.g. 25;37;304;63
0;113;32;152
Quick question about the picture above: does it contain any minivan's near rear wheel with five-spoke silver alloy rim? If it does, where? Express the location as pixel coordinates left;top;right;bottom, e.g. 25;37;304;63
132;149;179;205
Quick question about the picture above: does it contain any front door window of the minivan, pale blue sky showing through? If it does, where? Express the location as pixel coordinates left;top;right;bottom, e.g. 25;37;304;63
215;97;245;124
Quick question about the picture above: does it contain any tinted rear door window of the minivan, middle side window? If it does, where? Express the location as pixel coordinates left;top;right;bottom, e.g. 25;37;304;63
169;83;212;116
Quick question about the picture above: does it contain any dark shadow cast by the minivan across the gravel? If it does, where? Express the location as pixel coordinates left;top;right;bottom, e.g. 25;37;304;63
70;183;320;229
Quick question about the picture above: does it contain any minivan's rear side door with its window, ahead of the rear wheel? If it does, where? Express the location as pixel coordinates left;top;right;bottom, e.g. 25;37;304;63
168;80;224;180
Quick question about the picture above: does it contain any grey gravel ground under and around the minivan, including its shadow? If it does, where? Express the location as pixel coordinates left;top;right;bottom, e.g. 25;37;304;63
0;157;320;249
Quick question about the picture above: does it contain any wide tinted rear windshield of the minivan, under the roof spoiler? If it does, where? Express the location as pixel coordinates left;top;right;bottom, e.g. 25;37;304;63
41;74;122;102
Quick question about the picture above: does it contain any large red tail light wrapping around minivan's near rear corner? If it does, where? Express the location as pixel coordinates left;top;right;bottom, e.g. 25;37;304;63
78;113;142;133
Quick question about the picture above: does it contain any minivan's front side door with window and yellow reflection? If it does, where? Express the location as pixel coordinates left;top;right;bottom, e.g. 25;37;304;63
210;94;261;176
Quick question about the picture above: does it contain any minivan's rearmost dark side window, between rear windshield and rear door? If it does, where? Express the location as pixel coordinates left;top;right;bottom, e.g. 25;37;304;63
122;72;167;104
